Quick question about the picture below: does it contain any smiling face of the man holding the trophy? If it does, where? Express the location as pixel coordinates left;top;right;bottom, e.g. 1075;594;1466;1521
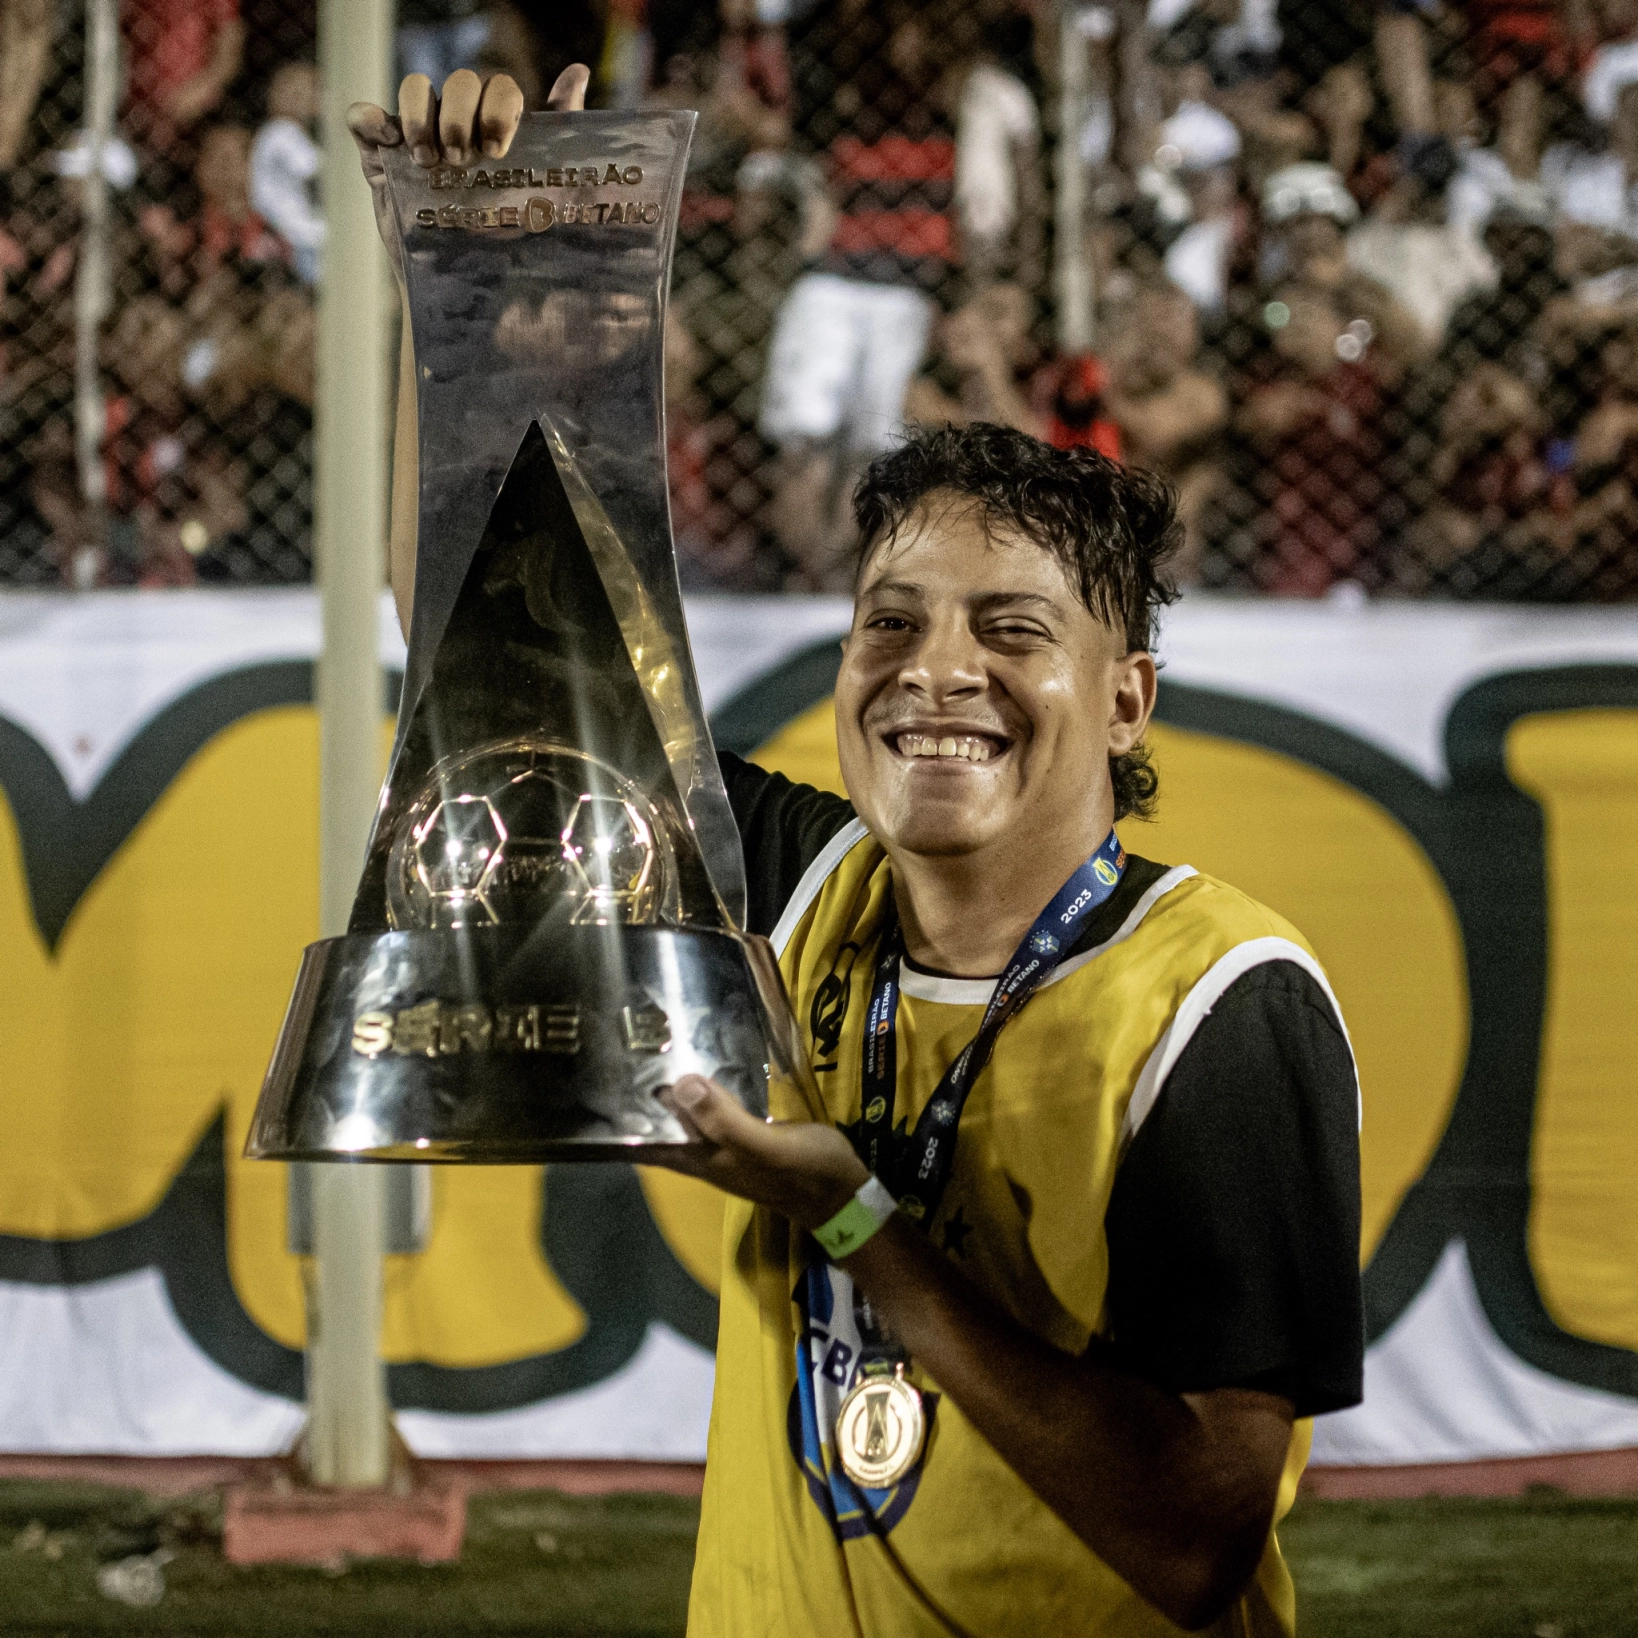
835;493;1155;875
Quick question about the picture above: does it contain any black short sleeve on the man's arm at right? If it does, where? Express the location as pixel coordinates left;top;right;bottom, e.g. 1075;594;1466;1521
1106;962;1364;1417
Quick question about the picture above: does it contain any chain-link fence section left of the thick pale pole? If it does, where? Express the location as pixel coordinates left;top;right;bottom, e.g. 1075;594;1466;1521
0;0;321;585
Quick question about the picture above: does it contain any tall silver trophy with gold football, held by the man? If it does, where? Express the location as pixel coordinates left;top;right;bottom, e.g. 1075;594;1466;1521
246;113;808;1163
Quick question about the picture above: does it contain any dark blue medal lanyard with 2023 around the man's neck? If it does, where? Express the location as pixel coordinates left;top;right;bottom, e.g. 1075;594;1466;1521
860;830;1125;1227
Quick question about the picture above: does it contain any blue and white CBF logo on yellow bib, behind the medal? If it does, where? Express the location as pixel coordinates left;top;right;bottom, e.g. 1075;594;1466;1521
786;1263;939;1541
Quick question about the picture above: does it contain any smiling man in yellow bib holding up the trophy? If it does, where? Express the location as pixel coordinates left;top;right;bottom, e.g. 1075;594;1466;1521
352;70;1361;1638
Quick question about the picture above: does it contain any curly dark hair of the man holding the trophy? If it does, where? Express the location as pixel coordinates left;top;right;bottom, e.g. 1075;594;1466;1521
853;421;1183;819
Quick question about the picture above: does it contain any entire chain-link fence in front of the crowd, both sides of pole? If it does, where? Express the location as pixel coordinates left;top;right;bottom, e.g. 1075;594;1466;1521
0;0;1638;601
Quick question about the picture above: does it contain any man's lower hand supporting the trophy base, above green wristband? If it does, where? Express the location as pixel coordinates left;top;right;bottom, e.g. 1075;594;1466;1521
644;1075;870;1232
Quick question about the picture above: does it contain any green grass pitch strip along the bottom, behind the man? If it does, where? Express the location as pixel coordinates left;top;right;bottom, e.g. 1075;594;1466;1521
0;1481;1638;1638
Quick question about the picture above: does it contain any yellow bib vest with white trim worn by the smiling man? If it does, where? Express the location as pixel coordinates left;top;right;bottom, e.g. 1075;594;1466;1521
688;824;1349;1638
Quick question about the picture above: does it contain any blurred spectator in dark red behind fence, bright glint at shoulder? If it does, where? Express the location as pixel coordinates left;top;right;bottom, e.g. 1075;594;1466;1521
1237;285;1384;598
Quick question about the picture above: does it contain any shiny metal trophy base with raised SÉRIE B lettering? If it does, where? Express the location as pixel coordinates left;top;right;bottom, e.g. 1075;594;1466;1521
244;922;803;1165
